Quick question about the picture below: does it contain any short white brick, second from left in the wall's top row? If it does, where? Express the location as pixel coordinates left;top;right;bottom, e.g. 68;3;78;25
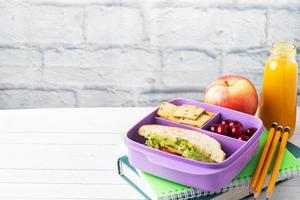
86;7;143;44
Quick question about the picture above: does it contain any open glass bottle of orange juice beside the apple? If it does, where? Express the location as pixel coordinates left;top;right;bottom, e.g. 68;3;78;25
259;42;298;137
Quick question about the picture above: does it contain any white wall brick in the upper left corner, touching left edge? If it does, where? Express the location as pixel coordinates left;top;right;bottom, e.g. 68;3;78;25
0;6;83;44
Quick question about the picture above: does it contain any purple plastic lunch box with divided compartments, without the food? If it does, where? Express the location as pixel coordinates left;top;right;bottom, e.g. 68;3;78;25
125;99;264;192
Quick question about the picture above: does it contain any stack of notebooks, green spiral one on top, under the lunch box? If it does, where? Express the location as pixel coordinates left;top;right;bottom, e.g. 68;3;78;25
118;131;300;200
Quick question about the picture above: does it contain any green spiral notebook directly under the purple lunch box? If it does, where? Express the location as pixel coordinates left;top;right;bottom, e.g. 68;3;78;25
121;131;300;199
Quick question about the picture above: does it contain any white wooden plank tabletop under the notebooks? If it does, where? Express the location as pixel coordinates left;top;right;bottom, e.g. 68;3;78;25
0;108;300;200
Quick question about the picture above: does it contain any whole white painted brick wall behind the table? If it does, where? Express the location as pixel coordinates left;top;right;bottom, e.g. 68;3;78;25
0;0;300;108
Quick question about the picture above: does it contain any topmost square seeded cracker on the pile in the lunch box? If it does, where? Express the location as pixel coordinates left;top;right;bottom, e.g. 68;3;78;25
173;104;205;120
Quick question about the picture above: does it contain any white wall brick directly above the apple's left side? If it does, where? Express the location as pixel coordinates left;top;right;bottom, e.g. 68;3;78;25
161;50;220;87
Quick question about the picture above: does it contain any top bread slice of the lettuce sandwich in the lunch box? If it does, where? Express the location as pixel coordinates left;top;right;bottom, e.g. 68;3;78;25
139;124;226;163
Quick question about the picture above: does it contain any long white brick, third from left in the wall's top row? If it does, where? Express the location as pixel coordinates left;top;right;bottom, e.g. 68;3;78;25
150;8;266;47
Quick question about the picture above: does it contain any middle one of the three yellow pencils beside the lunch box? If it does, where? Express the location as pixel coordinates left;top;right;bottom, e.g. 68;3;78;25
254;126;283;199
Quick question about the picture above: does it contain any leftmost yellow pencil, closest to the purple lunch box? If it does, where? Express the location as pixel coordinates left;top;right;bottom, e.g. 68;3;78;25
249;122;278;193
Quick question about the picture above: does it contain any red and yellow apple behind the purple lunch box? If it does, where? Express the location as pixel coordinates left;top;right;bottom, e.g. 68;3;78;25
204;75;258;115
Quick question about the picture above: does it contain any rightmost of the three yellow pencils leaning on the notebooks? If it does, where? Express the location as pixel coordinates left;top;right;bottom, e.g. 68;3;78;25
267;127;290;199
